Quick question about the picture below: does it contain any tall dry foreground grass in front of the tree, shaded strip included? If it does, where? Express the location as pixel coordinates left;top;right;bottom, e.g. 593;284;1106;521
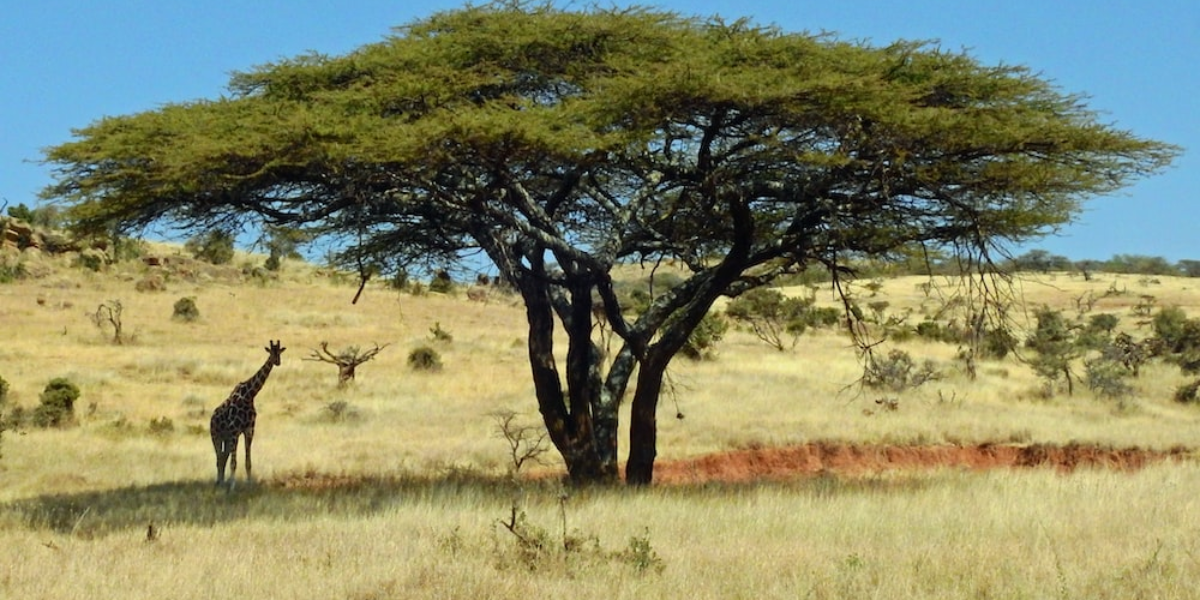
0;464;1200;599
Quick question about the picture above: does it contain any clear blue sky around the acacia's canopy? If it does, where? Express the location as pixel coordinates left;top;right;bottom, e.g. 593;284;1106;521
0;0;1200;260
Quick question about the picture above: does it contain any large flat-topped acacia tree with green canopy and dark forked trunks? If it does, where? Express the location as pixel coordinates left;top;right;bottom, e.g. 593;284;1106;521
46;2;1177;484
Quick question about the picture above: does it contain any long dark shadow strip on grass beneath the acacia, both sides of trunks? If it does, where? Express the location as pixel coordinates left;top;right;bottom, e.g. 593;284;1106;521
0;463;960;539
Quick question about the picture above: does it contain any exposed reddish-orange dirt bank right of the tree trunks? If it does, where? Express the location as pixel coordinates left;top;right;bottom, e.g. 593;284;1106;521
654;442;1192;485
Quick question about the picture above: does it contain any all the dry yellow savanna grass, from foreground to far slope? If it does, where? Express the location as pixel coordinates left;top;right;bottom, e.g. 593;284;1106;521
0;246;1200;599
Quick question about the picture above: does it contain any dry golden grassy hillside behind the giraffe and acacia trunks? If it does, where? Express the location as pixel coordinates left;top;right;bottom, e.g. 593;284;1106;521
0;246;1200;498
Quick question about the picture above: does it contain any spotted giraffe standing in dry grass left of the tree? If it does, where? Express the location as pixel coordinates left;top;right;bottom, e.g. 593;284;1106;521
209;341;287;490
